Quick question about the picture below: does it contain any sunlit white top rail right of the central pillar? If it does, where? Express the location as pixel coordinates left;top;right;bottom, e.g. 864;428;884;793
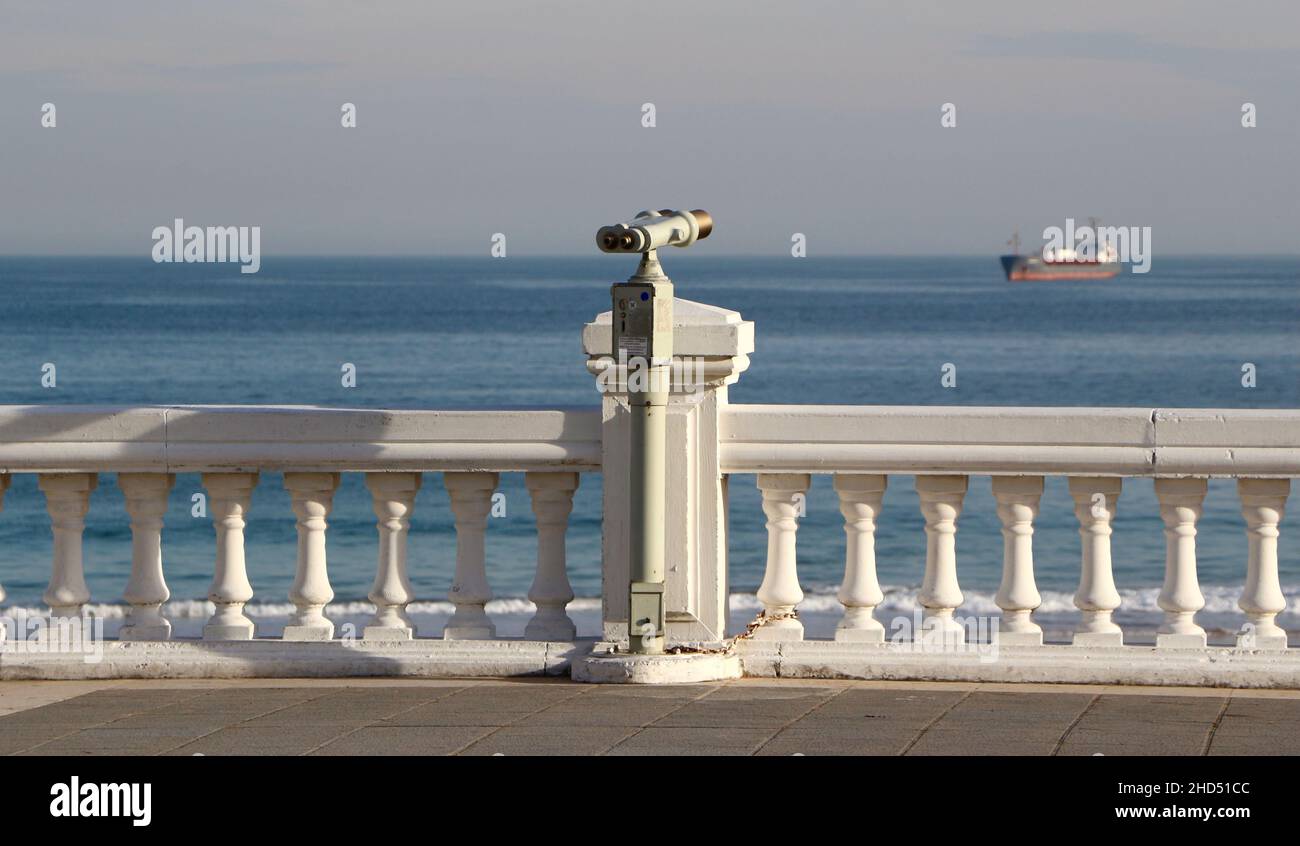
720;405;1300;477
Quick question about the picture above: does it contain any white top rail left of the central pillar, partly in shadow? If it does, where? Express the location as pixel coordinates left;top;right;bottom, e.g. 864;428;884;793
0;405;601;473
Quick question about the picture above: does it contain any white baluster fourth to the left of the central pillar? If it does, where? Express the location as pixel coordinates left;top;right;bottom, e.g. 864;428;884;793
283;473;339;641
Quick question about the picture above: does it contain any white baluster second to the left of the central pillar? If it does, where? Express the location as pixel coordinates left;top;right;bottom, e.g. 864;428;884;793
442;473;498;641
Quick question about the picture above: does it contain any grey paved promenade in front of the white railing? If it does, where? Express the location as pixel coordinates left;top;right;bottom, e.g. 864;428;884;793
0;680;1300;755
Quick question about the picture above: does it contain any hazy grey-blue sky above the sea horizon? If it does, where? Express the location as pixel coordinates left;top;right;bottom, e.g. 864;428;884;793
0;0;1300;257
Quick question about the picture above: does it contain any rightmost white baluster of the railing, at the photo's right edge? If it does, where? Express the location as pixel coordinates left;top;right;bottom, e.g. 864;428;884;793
1236;478;1291;650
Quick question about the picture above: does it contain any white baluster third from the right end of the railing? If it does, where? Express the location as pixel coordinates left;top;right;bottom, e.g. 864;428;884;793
1070;476;1125;646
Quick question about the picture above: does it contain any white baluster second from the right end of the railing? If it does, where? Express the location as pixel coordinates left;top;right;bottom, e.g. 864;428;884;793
1156;478;1206;648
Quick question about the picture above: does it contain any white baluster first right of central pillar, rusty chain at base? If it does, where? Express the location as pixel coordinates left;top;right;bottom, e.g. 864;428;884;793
754;473;813;641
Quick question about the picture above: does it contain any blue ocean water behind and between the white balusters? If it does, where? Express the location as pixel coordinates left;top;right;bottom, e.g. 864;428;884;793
0;258;1300;634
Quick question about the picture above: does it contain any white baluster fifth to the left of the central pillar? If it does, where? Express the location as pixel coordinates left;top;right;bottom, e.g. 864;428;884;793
203;473;257;641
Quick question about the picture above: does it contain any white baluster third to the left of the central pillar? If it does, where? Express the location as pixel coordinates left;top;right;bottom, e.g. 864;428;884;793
361;473;423;641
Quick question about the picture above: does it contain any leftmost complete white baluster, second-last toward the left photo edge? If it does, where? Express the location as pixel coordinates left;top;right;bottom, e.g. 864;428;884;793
39;473;99;619
